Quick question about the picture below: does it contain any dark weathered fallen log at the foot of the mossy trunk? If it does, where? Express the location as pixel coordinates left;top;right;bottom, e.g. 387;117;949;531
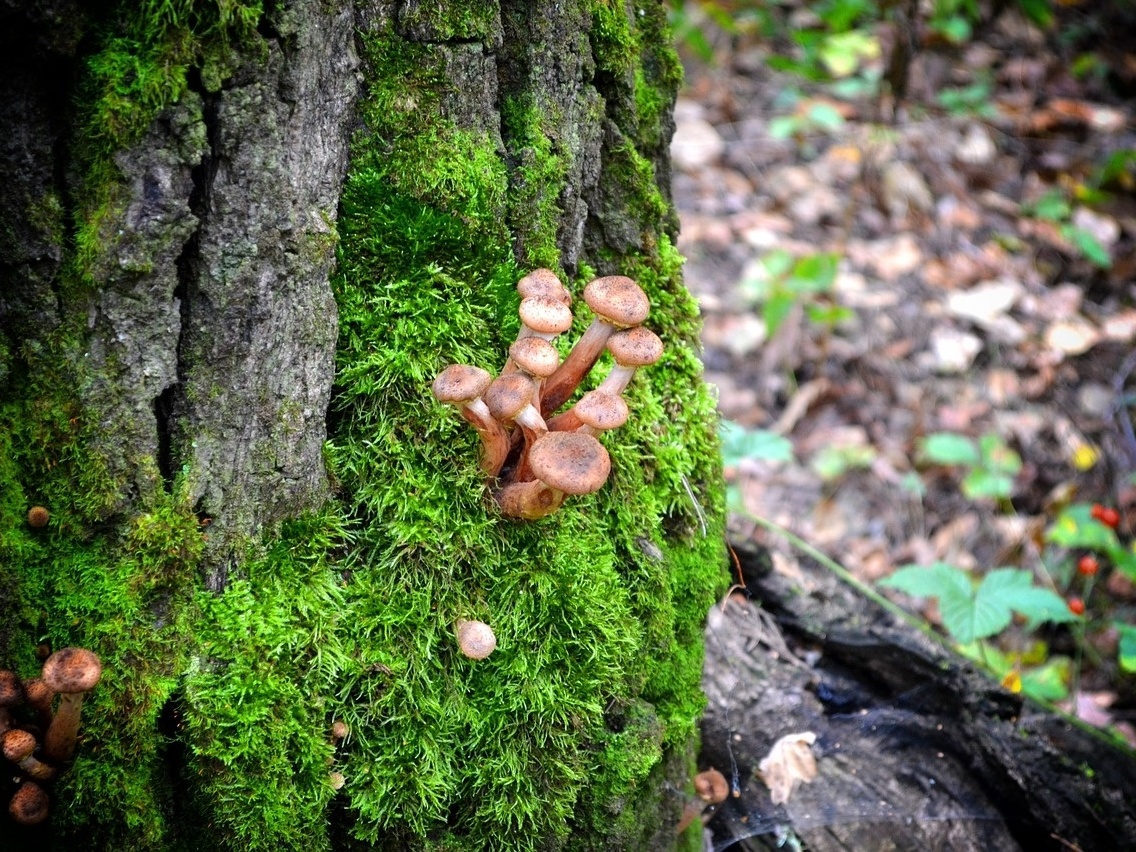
701;545;1136;852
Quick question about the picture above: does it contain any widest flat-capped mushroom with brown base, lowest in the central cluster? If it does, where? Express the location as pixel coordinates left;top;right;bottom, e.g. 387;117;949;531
494;432;611;520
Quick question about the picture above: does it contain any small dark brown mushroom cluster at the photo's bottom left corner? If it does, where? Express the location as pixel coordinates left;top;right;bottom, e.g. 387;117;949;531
0;648;102;826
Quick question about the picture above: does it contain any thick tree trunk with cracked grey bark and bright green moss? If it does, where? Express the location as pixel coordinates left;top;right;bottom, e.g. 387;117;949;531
0;0;724;850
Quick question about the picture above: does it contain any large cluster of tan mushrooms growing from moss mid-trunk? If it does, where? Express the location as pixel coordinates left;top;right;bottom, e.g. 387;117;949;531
434;269;662;519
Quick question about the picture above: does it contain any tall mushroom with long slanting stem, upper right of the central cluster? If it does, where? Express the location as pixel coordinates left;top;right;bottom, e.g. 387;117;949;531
541;275;651;417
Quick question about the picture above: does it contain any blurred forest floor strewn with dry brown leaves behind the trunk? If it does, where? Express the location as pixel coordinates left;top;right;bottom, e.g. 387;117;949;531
673;6;1136;738
